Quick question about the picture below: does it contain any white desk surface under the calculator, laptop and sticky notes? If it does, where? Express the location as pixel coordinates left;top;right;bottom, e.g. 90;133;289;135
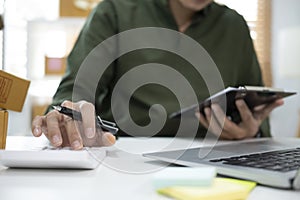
0;137;300;200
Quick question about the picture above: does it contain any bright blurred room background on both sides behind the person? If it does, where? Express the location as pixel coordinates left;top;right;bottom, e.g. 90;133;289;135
0;0;300;137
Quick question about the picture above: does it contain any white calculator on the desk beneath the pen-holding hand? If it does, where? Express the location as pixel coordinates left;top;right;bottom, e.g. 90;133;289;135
0;147;106;169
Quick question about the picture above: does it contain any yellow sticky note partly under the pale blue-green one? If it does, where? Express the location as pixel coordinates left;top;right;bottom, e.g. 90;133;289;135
157;178;256;200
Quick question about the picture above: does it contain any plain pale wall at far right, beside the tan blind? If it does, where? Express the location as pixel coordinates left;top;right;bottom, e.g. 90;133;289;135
271;0;300;136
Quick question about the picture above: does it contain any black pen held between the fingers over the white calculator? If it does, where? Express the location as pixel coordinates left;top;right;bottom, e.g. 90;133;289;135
52;105;119;135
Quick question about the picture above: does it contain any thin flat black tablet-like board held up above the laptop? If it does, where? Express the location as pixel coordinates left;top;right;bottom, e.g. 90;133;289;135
169;86;296;123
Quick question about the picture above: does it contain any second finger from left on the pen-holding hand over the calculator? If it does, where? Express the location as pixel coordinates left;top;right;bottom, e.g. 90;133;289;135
45;110;62;147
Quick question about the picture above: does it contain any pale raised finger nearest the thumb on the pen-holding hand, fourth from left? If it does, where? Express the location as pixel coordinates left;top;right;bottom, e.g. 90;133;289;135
75;101;96;138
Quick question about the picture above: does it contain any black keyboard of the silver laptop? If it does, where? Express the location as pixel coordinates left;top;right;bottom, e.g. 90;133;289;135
210;148;300;172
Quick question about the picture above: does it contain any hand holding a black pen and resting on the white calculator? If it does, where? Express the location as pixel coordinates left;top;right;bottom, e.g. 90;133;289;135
31;101;116;150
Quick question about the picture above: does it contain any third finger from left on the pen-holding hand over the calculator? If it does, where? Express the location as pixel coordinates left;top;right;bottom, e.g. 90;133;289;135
63;116;83;150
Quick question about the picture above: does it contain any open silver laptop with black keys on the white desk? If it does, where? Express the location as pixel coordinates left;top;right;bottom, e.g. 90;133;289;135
143;138;300;190
